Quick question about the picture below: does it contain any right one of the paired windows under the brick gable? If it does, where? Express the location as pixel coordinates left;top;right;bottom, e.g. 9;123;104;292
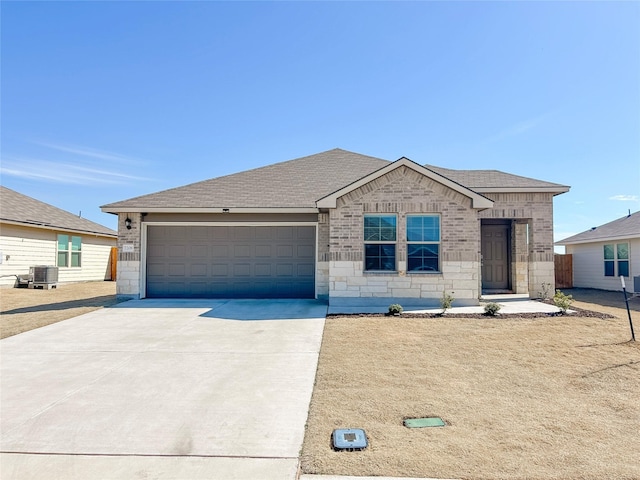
407;215;440;272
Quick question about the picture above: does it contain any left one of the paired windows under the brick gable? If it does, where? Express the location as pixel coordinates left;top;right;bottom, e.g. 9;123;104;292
364;215;397;271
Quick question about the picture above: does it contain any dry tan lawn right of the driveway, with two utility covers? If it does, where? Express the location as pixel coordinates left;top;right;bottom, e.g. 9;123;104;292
302;289;640;479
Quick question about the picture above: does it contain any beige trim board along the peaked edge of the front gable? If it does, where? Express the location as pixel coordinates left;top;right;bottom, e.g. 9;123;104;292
316;157;493;209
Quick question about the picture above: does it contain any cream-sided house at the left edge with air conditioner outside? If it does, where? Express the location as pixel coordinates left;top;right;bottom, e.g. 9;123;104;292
0;186;118;285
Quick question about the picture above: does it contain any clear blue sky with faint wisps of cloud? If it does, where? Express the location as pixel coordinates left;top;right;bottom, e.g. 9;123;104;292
1;2;640;248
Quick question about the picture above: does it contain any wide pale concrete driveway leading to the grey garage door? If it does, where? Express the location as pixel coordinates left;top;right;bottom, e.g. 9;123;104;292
0;300;327;480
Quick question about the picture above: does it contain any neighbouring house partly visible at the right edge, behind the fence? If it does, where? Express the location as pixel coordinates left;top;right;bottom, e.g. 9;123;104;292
556;212;640;292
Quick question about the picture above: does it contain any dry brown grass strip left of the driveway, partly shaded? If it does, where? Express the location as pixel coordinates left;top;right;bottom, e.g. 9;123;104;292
0;282;118;338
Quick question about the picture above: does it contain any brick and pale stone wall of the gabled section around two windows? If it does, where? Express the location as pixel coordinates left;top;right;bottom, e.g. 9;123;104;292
329;167;480;306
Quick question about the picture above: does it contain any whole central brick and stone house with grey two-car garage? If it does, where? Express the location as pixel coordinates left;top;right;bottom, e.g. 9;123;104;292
101;149;569;306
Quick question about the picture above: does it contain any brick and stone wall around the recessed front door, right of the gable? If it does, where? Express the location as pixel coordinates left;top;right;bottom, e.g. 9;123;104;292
479;193;555;296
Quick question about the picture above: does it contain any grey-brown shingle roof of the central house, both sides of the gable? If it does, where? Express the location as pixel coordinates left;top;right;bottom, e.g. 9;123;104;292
101;148;568;213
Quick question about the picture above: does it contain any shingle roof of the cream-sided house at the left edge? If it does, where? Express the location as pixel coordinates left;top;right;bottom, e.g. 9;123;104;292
0;186;118;237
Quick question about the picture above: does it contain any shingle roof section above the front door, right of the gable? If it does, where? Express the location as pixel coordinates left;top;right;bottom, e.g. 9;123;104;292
425;165;568;191
